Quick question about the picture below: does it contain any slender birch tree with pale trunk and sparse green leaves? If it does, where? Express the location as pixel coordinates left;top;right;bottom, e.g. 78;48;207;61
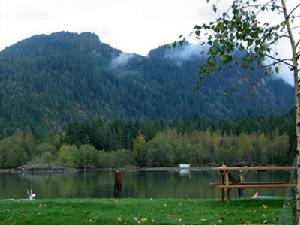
174;0;300;221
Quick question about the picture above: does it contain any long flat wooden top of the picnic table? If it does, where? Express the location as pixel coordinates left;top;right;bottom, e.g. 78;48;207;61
212;166;297;171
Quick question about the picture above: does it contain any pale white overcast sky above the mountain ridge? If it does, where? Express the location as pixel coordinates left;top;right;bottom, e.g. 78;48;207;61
0;0;298;84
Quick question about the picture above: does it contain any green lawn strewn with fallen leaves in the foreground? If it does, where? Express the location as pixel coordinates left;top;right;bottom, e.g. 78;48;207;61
0;199;291;225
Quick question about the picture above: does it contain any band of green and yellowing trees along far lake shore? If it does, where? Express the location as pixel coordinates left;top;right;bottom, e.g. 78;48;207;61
0;112;294;169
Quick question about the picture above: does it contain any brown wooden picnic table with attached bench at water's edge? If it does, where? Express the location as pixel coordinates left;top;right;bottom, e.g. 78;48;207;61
212;165;297;201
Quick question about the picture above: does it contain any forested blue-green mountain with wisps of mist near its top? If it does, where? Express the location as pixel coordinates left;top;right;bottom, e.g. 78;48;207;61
0;32;294;134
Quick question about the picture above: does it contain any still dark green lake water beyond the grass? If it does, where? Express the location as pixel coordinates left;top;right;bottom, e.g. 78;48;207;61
0;171;290;199
